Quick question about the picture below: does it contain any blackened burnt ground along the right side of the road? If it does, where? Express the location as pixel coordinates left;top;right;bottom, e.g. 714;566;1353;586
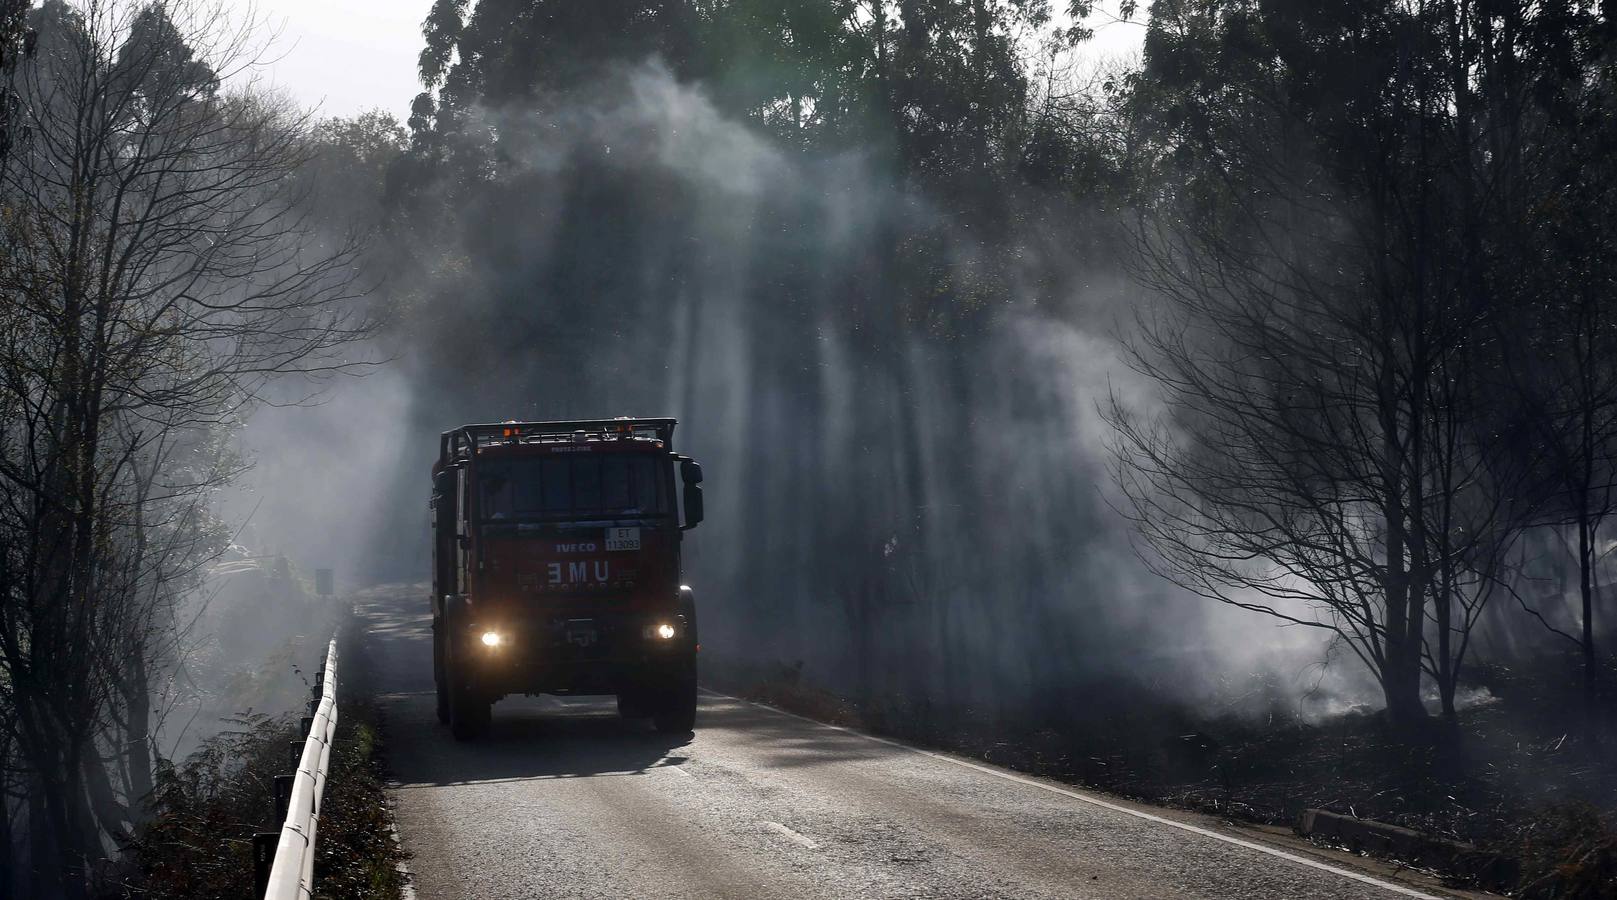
703;659;1617;897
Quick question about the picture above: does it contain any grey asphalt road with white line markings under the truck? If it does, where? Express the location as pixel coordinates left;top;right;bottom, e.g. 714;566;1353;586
361;590;1481;900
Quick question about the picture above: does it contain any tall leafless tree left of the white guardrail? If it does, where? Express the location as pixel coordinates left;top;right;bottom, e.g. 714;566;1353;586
0;0;370;897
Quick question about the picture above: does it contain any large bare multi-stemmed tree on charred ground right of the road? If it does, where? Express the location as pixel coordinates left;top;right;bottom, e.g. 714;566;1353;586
1109;0;1559;722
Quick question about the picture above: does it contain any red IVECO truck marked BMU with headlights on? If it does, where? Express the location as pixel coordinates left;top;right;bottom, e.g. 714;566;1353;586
432;418;702;740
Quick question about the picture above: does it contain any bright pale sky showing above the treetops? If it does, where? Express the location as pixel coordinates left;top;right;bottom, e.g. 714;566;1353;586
243;0;1145;121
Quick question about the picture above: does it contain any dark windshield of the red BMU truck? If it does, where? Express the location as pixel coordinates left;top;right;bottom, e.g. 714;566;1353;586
477;454;669;519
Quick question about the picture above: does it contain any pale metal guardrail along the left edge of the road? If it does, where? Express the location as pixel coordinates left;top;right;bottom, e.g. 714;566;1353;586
252;640;336;900
